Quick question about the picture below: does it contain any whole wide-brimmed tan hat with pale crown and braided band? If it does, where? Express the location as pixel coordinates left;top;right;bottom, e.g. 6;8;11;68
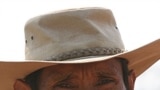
0;8;160;90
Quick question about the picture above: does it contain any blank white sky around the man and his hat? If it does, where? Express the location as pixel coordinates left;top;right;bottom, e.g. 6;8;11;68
0;0;160;90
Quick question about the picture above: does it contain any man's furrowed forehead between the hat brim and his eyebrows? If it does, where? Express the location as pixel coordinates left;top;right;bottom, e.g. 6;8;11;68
40;59;121;75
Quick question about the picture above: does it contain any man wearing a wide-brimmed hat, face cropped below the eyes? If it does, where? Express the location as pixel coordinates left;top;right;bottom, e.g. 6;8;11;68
0;8;160;90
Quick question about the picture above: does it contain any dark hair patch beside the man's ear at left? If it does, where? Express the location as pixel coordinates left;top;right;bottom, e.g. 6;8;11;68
24;69;43;90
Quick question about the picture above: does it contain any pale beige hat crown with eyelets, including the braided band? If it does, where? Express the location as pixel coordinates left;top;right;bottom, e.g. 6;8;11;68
25;8;124;60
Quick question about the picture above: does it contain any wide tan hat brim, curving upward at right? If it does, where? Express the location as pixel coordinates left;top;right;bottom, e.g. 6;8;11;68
0;39;160;90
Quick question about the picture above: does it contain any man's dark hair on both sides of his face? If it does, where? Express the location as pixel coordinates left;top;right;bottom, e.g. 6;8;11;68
24;58;129;90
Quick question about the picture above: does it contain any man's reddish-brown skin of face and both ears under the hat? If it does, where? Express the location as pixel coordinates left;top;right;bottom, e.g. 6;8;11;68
14;59;135;90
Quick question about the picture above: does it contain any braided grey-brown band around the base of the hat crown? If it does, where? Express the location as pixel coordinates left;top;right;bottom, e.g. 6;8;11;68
47;47;124;61
